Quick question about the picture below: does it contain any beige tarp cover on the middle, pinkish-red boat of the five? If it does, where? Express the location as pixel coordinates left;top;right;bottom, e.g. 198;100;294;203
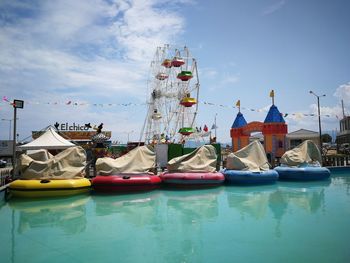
168;145;217;173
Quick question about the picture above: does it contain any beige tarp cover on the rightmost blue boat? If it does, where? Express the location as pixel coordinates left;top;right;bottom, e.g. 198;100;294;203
280;140;322;167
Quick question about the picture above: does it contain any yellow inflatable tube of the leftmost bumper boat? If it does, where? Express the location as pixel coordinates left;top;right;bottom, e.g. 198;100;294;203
9;178;91;197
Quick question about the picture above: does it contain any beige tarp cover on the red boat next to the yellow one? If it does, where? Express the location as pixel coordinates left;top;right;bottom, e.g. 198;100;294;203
96;146;156;175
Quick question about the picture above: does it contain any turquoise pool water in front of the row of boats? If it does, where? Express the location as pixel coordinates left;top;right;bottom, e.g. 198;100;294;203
0;170;350;263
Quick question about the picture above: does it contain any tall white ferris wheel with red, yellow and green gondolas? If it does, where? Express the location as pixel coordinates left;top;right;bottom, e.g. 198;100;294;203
145;45;199;143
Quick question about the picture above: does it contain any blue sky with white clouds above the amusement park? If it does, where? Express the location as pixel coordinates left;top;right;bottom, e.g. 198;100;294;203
0;0;350;142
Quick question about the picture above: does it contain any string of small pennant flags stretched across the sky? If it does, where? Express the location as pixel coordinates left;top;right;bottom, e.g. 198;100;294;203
0;96;339;119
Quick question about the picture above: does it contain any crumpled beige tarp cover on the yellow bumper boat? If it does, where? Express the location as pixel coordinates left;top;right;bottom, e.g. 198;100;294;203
17;146;86;179
